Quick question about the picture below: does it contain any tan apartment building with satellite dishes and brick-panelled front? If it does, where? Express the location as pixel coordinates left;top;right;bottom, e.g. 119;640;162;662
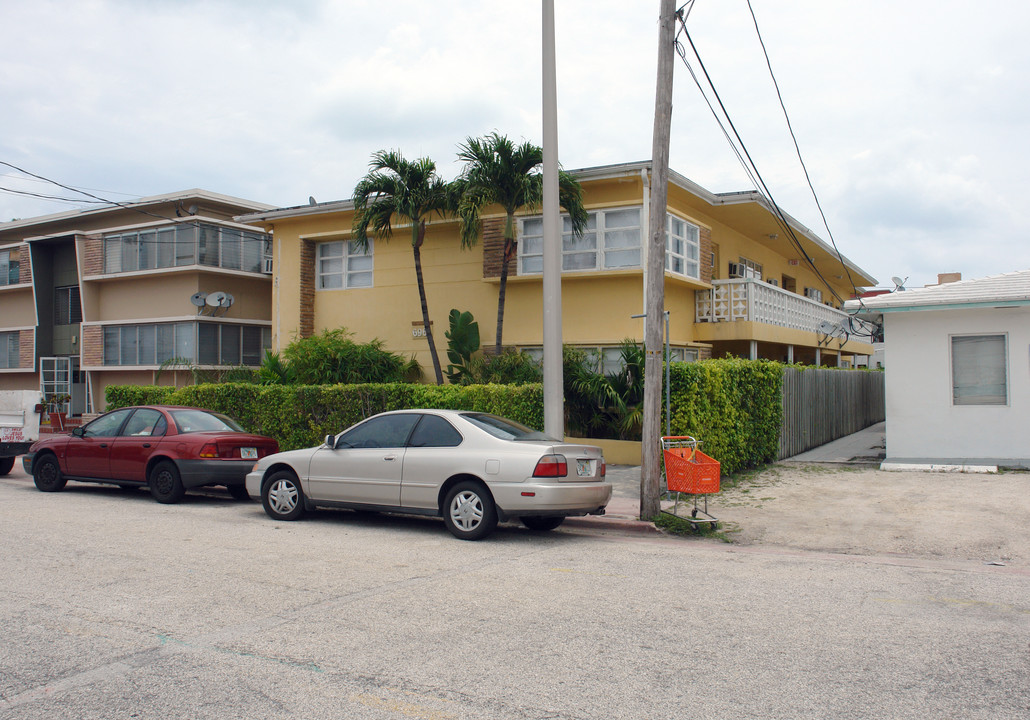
0;190;272;415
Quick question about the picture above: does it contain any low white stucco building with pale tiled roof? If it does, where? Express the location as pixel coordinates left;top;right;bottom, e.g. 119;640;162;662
847;270;1030;468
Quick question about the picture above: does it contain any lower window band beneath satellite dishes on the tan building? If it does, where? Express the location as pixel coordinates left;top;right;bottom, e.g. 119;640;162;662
104;322;272;366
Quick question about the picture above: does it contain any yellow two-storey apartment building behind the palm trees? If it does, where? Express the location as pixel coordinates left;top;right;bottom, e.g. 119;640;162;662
236;163;876;377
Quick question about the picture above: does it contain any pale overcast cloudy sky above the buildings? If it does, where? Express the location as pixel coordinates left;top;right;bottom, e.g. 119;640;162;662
0;0;1030;286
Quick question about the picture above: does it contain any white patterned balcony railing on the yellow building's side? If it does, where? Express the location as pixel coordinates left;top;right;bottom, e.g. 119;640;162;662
694;278;864;334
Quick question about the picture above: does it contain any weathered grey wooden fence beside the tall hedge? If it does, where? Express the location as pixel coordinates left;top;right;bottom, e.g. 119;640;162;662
779;367;886;459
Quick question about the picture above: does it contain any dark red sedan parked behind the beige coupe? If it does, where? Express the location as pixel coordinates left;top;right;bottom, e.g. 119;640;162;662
22;405;279;503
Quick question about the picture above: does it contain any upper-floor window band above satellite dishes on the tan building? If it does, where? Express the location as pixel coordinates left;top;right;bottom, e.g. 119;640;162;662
104;222;268;273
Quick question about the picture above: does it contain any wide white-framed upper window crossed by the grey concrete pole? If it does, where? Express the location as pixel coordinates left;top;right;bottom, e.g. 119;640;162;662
518;207;641;275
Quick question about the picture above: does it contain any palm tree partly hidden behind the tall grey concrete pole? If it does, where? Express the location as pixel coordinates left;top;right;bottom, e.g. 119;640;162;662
453;132;587;354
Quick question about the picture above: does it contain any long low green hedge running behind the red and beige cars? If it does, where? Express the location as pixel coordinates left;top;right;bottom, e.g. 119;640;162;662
106;383;544;450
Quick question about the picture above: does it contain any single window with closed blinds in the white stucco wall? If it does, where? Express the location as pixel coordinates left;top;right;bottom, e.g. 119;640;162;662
952;335;1008;405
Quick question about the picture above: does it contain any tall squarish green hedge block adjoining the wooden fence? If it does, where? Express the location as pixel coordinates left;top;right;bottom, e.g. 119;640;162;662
662;359;783;474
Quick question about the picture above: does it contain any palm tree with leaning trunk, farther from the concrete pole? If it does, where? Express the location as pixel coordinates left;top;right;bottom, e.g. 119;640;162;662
353;150;455;385
